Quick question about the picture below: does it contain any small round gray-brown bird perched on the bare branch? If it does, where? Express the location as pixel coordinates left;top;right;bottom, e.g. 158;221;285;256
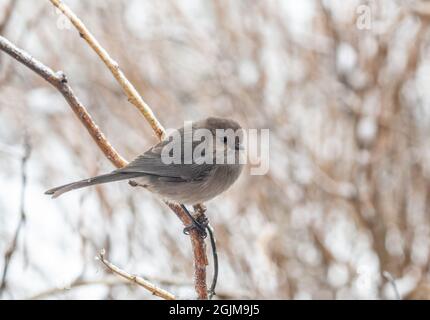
45;117;243;205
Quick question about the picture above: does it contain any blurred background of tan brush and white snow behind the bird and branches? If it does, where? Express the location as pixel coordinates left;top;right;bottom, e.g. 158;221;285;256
0;0;430;299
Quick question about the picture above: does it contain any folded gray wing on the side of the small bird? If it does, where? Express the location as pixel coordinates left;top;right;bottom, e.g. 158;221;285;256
117;133;213;182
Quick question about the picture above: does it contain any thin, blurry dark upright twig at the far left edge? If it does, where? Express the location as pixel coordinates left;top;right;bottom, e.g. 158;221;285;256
0;133;31;296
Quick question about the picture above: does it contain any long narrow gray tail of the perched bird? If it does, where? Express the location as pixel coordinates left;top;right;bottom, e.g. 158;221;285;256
45;171;142;198
